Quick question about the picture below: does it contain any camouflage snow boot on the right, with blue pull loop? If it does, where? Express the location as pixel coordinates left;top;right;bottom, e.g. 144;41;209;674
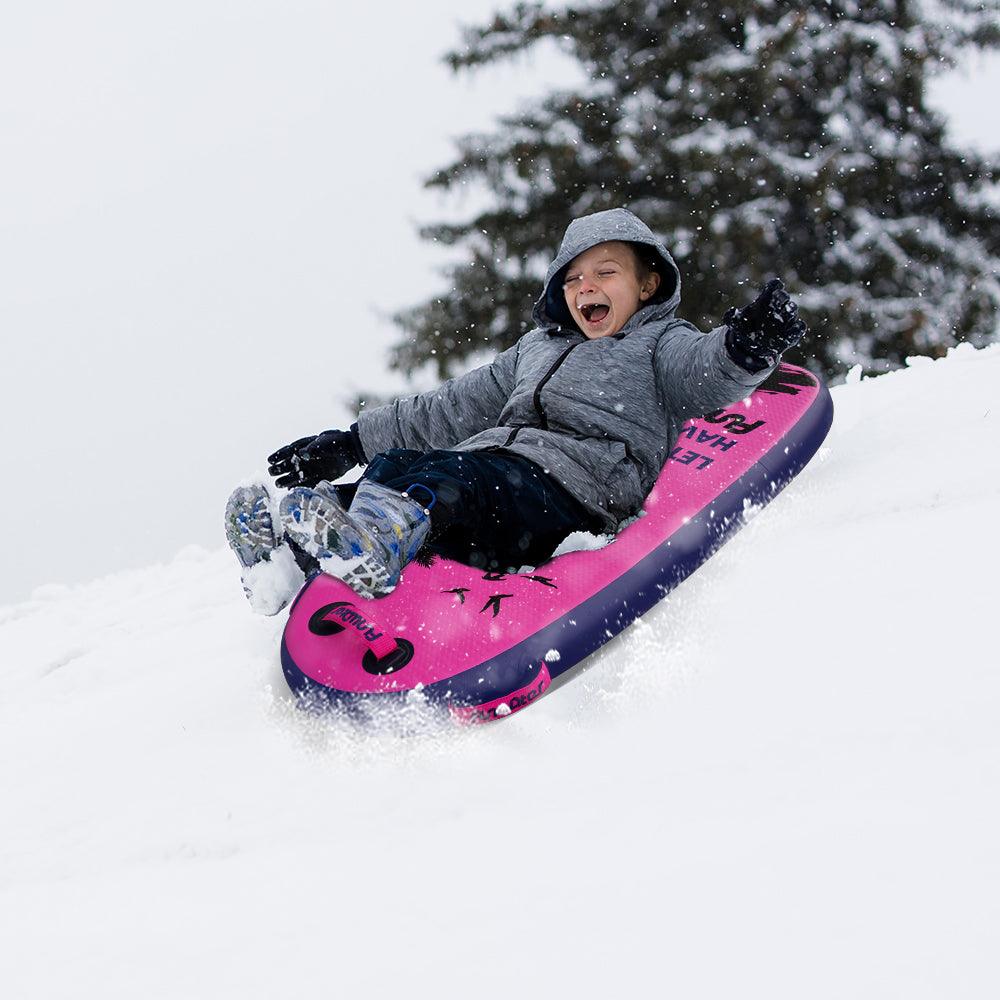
280;479;435;597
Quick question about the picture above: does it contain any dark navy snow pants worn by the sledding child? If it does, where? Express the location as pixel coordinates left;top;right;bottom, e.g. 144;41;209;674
339;448;604;572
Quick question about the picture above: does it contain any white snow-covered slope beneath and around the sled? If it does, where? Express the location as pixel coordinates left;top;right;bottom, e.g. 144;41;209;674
0;347;1000;1000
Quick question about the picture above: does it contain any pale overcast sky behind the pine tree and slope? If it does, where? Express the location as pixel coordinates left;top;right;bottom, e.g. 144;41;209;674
0;0;1000;603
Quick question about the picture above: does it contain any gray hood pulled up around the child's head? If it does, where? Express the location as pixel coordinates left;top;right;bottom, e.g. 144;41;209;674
531;208;681;330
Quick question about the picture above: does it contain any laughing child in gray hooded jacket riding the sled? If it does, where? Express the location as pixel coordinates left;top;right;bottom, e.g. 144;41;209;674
226;208;805;613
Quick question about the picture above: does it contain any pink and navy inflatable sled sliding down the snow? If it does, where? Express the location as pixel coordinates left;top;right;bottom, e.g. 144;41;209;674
281;365;833;722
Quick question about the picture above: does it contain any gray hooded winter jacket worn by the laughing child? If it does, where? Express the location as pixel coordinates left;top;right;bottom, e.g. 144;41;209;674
358;208;772;530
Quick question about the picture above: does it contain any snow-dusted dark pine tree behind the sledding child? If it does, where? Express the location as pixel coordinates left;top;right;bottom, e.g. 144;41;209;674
393;0;1000;377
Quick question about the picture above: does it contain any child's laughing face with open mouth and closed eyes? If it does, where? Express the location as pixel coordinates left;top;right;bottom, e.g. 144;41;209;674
563;240;660;340
